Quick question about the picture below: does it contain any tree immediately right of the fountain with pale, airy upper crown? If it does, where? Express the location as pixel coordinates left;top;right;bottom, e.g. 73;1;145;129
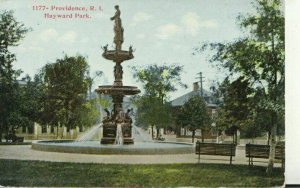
132;64;186;136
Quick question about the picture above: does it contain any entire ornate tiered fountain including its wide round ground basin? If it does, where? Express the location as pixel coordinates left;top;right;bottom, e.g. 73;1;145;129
31;6;195;155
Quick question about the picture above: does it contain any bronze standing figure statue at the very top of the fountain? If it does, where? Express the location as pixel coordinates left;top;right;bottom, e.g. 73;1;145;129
110;5;124;51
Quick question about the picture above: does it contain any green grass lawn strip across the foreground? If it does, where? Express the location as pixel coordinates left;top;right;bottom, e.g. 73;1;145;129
0;159;284;187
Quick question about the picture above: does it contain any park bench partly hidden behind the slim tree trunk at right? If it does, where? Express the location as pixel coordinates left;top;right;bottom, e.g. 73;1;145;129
246;144;285;168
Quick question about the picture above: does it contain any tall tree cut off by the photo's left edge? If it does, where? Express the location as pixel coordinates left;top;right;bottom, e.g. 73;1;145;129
0;11;29;142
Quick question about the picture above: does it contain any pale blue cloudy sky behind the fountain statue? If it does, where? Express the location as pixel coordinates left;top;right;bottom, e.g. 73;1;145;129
0;0;253;99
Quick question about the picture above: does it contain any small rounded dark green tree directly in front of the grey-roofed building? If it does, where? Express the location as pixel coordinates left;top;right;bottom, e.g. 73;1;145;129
178;96;211;143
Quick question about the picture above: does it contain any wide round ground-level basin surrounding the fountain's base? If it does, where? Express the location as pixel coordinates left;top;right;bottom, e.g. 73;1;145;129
31;140;195;155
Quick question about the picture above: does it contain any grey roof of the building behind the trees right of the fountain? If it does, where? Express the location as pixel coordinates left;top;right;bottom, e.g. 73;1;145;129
171;89;217;107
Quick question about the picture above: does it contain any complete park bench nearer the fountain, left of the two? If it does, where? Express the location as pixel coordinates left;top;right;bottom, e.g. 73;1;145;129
196;141;236;164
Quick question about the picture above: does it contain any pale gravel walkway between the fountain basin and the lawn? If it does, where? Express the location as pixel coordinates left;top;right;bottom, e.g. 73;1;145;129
0;145;281;167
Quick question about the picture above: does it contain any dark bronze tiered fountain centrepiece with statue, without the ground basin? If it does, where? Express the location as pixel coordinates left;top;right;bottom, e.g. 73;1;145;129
96;5;140;144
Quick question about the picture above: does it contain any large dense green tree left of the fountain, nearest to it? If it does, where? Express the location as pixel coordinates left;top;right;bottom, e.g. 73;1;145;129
42;55;90;132
